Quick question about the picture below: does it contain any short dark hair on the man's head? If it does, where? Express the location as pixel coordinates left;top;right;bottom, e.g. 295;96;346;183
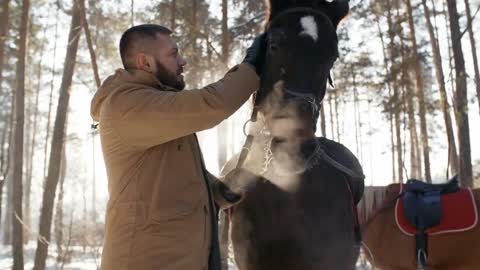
119;24;172;68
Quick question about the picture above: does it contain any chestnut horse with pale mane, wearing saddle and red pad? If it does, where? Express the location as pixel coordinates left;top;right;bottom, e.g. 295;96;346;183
358;184;480;270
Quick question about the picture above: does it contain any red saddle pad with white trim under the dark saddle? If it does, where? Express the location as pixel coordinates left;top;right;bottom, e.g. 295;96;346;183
395;184;478;236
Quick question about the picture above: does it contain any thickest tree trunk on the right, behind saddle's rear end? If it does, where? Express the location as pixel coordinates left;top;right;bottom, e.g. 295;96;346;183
447;0;473;187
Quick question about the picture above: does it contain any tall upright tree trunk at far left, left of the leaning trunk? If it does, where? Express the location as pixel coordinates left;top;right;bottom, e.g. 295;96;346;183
12;0;30;270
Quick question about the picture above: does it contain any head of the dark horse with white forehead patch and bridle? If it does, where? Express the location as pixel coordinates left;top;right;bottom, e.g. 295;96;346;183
256;0;349;143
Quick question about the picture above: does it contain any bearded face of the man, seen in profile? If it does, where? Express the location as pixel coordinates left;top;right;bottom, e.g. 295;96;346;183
153;34;187;90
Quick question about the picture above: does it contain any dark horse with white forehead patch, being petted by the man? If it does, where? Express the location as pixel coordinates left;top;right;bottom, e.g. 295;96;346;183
220;0;363;270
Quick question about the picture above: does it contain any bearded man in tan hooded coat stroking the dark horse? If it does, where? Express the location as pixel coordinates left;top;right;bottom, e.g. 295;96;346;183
91;25;264;270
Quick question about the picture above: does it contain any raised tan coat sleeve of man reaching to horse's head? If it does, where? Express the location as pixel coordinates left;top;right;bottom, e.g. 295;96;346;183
109;64;259;148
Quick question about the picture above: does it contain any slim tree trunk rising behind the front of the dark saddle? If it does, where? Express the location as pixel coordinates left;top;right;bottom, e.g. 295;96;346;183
407;0;432;182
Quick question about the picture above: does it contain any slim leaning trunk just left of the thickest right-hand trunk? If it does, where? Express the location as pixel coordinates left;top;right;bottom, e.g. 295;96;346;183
422;0;458;175
